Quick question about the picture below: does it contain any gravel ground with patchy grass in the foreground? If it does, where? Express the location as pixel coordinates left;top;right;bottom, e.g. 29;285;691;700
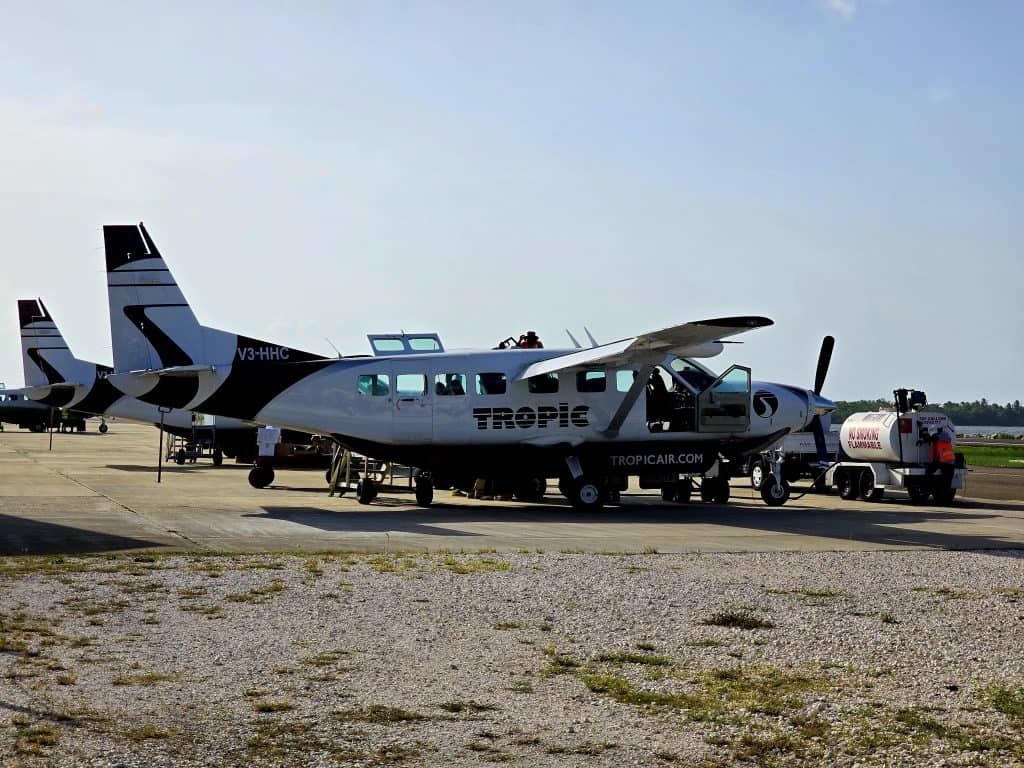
0;551;1024;768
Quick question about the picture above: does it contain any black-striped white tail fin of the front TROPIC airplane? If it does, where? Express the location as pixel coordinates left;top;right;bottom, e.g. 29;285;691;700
103;223;214;371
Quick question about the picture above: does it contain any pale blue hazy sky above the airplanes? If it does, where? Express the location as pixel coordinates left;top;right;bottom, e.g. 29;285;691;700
0;0;1024;402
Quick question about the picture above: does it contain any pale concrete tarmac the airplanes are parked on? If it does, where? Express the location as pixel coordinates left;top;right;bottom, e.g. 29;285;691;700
0;421;1024;555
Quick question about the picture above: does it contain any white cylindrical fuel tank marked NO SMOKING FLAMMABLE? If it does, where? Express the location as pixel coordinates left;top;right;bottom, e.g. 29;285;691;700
839;411;956;464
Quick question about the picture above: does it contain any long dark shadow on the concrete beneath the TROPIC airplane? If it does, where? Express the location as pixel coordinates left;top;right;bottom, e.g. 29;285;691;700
251;502;1024;555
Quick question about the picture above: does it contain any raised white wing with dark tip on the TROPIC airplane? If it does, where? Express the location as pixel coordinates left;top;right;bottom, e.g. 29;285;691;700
516;316;773;380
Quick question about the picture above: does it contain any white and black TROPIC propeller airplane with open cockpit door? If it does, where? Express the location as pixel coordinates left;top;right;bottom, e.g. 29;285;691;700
103;224;835;509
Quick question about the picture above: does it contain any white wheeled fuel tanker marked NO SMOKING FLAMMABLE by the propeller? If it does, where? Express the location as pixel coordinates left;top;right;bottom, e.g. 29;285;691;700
825;389;967;504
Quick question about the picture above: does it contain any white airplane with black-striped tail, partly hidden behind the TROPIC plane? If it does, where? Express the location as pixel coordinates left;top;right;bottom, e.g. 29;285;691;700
17;299;272;464
